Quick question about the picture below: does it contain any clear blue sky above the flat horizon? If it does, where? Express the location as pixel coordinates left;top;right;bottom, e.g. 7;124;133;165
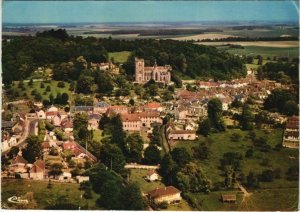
2;0;299;23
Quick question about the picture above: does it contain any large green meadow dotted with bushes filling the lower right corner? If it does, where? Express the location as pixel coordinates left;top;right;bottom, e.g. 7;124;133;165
173;129;299;210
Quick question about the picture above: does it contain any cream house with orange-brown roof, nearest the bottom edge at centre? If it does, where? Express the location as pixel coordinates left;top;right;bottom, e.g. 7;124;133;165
148;186;182;204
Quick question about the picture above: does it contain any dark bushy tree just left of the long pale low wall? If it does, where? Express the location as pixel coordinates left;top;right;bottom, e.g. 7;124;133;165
100;144;125;173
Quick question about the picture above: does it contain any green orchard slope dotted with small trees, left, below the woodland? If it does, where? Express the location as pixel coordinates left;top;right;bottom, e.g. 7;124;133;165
12;80;71;100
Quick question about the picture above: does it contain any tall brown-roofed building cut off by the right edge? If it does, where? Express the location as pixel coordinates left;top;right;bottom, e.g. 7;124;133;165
282;116;299;148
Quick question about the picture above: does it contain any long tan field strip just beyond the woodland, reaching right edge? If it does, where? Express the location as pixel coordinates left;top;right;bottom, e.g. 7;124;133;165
197;41;299;48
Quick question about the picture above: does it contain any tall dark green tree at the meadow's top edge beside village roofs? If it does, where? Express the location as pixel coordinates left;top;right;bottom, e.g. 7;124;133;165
207;98;225;131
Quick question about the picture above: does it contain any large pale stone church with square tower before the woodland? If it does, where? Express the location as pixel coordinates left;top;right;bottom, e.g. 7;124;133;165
134;58;172;84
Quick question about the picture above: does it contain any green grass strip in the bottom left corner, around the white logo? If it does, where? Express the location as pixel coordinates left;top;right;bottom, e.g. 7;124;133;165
1;180;99;209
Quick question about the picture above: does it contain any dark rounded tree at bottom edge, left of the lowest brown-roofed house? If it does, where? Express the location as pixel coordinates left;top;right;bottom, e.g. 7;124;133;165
121;183;145;211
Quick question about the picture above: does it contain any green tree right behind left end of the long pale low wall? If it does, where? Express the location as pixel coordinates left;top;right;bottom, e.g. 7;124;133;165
125;133;144;163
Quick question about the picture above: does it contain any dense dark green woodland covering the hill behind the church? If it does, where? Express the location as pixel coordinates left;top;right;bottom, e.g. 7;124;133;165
2;30;246;85
